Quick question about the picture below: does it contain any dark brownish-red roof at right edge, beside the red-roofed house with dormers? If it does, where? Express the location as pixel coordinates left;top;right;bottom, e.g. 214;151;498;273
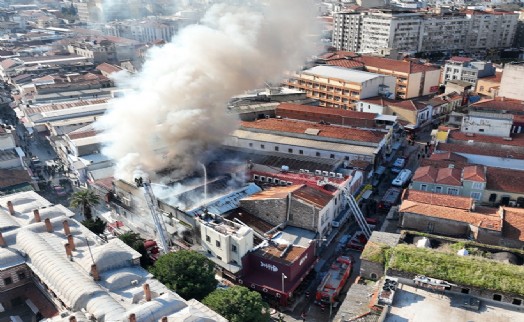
486;167;524;194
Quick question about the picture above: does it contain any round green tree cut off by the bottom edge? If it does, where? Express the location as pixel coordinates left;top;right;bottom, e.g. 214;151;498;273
202;286;269;322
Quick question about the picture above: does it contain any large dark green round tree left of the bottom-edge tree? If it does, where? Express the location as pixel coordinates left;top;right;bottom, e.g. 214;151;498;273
151;250;217;301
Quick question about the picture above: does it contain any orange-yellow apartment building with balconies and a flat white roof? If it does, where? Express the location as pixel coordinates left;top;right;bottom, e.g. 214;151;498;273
286;66;395;109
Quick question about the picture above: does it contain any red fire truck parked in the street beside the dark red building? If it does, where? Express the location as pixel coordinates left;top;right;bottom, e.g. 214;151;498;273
315;256;352;303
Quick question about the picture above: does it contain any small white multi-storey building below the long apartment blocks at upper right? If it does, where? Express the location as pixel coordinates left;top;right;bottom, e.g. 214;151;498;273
442;57;496;85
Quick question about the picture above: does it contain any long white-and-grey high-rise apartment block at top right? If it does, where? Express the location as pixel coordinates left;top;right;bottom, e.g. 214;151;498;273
333;9;519;54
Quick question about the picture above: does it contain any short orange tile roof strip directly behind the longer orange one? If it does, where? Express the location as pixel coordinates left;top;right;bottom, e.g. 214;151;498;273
402;189;475;210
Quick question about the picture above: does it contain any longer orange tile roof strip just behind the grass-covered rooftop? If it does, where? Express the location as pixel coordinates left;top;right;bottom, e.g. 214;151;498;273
399;200;502;231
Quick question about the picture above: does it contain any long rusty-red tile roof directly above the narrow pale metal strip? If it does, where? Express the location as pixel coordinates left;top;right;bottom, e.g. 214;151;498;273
241;119;385;143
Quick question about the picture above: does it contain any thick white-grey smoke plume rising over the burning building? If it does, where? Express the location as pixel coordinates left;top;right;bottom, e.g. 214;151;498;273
99;0;316;180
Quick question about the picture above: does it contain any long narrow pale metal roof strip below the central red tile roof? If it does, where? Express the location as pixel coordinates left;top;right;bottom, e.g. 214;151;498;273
231;130;376;155
